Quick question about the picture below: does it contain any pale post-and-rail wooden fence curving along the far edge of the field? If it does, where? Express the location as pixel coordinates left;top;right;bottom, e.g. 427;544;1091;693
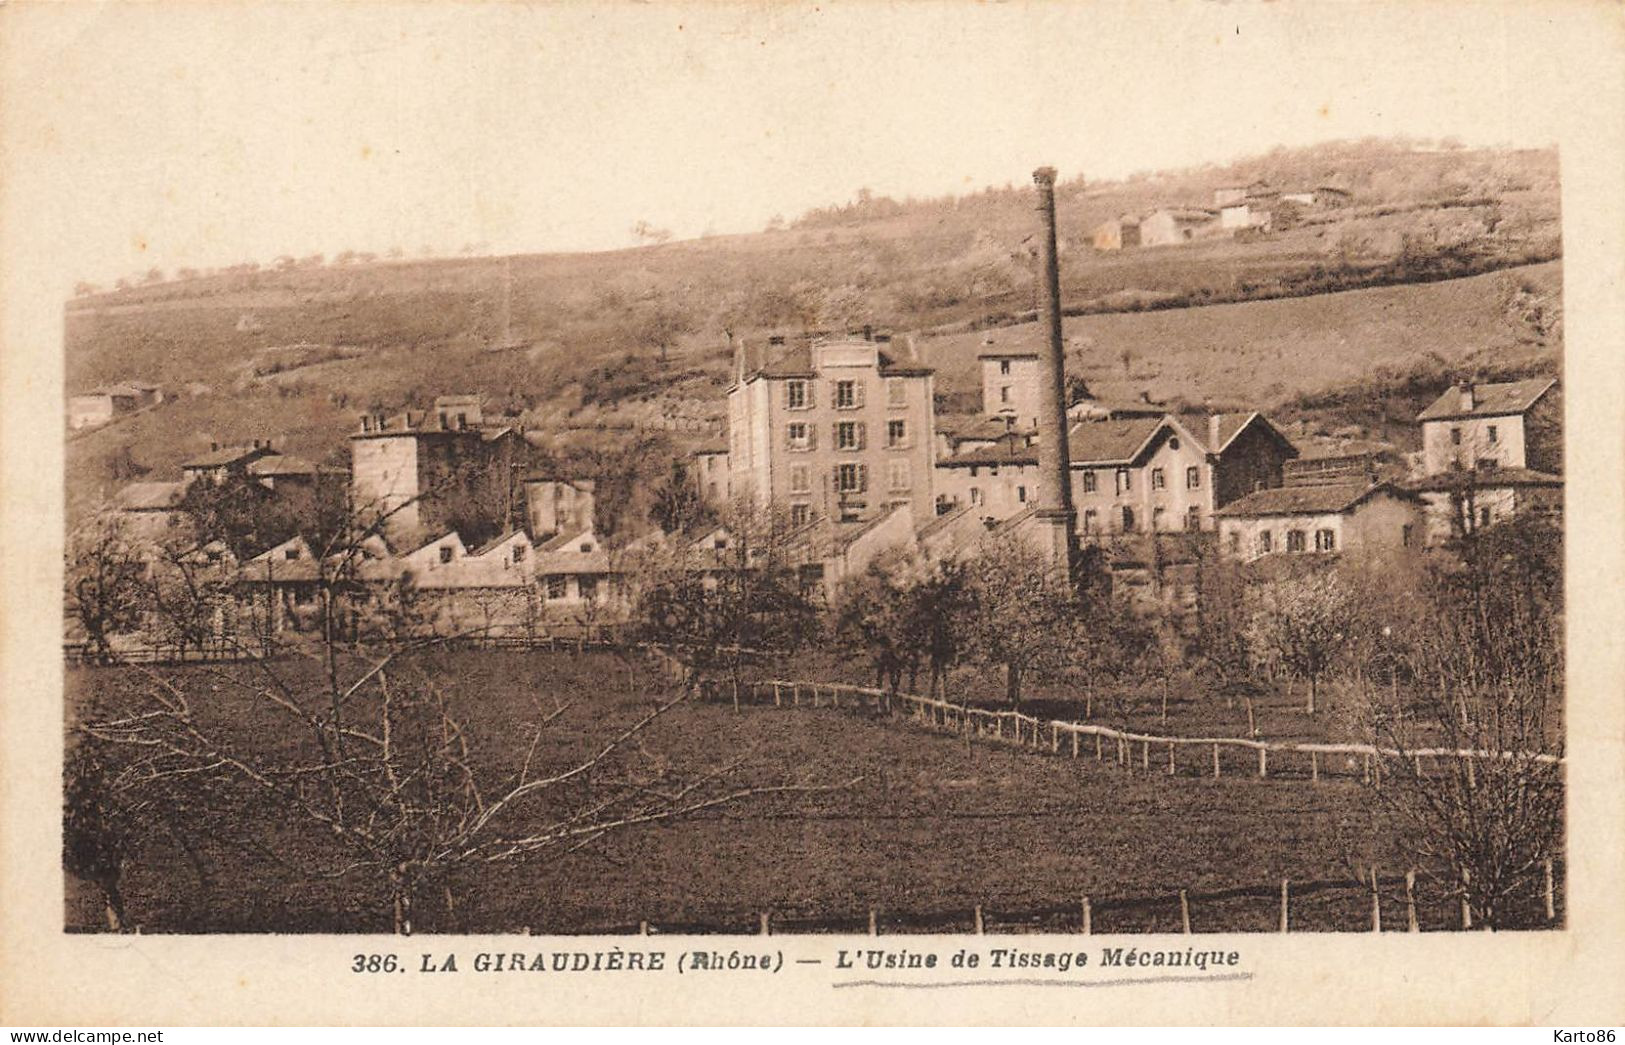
702;679;1562;787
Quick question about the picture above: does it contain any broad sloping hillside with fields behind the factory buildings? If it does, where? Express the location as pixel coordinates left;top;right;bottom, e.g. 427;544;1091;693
65;143;1560;515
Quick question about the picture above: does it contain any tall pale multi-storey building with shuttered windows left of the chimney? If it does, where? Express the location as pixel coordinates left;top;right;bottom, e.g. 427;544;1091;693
728;335;934;525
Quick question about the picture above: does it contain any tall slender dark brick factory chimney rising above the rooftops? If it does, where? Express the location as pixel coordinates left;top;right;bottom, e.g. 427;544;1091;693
1032;167;1077;570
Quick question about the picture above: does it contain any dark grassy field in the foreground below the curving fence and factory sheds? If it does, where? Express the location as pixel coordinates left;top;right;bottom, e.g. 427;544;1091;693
67;653;1560;933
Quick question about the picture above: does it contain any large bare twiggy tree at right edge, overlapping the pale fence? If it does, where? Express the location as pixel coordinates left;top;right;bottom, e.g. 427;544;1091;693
1362;514;1565;928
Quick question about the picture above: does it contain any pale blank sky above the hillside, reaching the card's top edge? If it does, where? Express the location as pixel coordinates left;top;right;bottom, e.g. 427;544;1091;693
5;2;1599;294
